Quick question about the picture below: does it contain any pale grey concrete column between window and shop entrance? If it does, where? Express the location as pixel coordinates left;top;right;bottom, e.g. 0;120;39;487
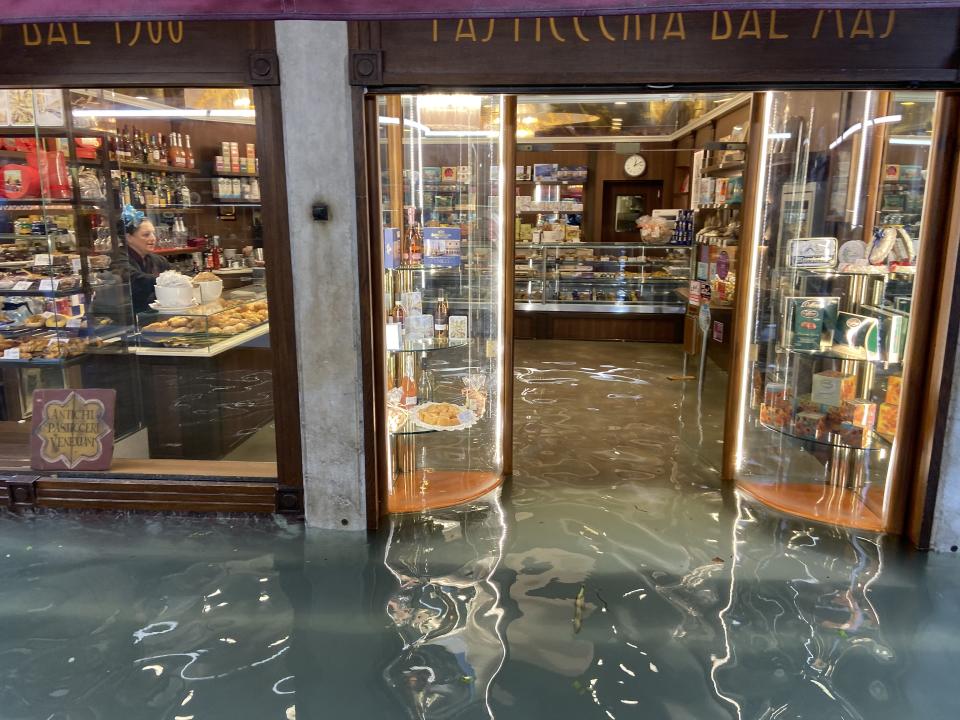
276;20;366;530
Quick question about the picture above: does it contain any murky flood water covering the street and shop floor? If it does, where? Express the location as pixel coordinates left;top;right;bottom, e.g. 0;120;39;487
0;342;960;720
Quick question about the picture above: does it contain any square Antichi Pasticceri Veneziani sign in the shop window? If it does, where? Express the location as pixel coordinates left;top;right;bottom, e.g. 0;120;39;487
30;389;117;470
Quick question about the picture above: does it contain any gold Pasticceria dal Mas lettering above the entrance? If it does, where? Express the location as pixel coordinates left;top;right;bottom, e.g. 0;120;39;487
432;9;897;44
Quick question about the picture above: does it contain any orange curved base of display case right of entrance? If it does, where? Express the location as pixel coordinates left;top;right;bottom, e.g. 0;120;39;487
737;482;884;532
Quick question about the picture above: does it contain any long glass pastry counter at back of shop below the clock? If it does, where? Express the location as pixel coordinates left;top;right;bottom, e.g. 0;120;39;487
514;243;691;314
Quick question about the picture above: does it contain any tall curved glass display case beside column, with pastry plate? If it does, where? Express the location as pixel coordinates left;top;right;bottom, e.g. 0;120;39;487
378;95;505;512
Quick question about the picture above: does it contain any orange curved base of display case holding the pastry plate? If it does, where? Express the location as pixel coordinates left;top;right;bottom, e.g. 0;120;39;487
387;470;503;513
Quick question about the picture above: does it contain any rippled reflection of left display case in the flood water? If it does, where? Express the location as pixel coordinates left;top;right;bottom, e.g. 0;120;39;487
383;490;506;718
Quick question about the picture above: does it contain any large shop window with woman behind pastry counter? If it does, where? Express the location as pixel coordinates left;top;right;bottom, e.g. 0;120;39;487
0;88;276;477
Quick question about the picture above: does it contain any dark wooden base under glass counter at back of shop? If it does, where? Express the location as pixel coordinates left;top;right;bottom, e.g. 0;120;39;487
513;311;683;343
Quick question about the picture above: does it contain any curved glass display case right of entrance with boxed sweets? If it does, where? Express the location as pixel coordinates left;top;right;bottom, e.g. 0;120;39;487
736;91;936;530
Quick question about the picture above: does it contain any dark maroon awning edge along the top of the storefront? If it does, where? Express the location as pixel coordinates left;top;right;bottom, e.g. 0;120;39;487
0;0;960;24
